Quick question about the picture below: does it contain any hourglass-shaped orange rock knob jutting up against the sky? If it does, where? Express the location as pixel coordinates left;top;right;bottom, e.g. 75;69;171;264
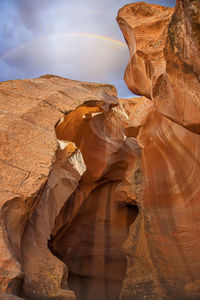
117;2;174;99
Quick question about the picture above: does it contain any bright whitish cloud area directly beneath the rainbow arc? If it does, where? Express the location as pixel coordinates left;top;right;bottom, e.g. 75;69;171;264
5;35;128;82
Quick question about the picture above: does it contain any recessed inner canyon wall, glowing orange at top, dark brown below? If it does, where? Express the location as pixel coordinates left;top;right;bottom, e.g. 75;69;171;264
50;97;148;300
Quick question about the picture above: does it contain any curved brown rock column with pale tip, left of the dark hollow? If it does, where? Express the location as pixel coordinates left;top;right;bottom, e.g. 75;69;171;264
21;144;86;299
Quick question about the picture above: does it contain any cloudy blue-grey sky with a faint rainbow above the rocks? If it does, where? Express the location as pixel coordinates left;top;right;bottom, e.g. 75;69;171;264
0;0;175;98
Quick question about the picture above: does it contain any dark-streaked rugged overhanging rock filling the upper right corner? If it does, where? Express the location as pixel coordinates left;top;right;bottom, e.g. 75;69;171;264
152;1;200;134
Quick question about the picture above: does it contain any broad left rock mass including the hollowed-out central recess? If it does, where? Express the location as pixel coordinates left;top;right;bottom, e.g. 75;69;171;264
0;75;148;300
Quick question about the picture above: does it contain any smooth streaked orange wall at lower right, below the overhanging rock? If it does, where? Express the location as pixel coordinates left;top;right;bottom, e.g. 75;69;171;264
121;111;200;299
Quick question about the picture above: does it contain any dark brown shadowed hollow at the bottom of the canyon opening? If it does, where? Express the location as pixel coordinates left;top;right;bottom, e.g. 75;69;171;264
49;181;138;300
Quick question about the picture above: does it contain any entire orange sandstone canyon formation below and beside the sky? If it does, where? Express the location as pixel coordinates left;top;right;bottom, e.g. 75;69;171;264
0;0;200;300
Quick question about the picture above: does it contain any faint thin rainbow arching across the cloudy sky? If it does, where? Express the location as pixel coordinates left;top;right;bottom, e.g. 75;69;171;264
0;32;127;60
